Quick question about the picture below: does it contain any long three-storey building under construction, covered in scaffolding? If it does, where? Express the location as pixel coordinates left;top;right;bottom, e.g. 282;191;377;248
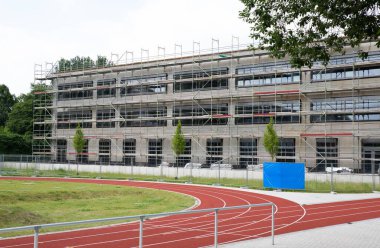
33;38;380;172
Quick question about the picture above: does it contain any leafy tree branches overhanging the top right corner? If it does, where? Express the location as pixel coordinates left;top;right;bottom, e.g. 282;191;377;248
240;0;380;67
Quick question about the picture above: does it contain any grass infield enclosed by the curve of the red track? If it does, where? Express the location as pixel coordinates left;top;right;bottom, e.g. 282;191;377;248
0;180;194;237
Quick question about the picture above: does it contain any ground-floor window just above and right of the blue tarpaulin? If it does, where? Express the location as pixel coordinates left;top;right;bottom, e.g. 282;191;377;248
314;138;339;171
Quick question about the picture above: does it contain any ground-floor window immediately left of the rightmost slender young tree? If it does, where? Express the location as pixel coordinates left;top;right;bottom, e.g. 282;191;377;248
239;138;257;168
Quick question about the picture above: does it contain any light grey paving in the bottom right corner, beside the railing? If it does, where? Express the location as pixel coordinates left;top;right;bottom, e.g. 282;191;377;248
219;218;380;248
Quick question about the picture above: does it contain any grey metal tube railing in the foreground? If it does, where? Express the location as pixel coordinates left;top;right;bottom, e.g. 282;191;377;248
0;202;275;248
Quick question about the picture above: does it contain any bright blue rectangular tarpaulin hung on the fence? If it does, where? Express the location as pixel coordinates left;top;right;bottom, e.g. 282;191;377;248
264;162;305;189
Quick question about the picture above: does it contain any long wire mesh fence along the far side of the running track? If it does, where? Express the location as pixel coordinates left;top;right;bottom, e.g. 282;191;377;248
0;154;380;193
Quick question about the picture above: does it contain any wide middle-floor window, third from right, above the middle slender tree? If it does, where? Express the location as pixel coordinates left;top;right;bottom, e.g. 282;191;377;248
173;103;228;126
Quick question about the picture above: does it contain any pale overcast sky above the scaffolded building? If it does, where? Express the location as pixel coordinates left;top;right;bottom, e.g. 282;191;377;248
0;0;250;96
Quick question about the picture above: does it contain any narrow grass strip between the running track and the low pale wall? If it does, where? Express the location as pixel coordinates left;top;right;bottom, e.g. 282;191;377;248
0;168;380;193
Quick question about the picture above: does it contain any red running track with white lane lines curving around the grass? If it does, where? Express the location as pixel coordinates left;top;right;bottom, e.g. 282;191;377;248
0;177;380;248
